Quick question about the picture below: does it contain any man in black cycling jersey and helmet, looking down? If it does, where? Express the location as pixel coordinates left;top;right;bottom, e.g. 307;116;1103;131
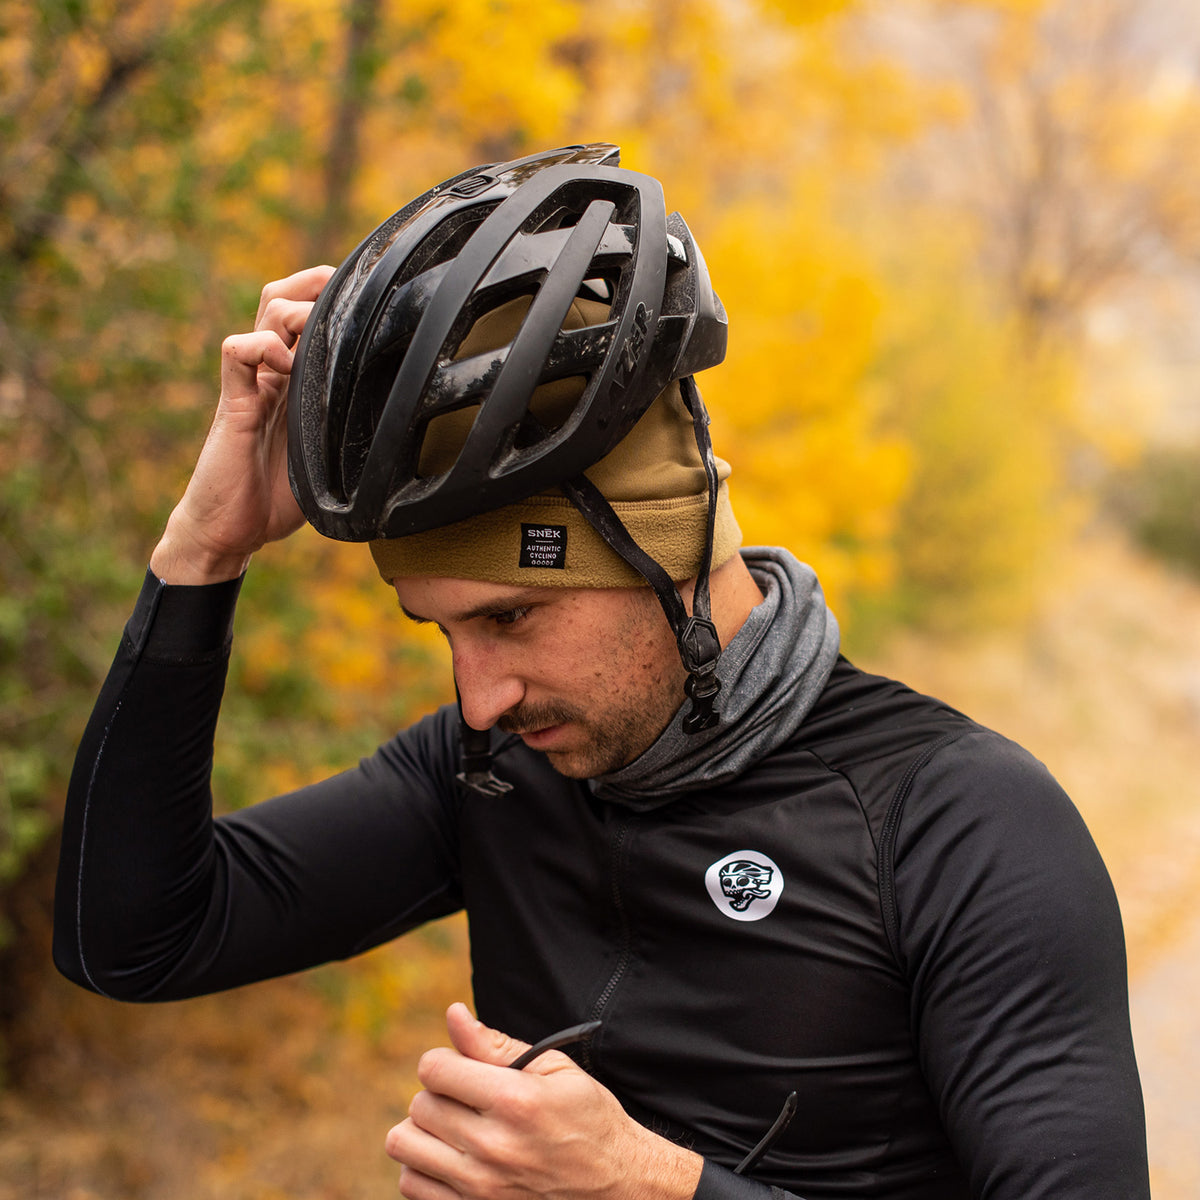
55;146;1148;1200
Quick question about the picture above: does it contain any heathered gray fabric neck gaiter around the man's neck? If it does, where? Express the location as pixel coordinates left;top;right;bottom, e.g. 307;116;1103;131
589;546;839;811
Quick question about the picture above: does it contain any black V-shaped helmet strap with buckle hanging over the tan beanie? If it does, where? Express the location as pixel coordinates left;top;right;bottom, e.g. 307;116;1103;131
562;376;721;733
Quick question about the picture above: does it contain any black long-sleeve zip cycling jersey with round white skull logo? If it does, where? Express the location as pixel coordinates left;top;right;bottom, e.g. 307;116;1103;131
55;578;1148;1200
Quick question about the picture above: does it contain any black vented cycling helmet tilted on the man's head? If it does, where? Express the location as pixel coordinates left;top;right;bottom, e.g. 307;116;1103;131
288;144;726;541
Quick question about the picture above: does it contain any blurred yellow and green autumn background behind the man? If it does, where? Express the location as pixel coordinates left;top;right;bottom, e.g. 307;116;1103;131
0;0;1200;1200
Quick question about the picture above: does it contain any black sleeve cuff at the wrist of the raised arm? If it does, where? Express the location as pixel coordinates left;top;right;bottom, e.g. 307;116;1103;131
125;570;245;662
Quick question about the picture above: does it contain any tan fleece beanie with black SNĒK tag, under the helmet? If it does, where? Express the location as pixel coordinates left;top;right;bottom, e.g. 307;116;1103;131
371;299;742;588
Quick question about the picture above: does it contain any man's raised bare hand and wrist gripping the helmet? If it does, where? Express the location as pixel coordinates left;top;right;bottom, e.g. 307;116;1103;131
150;266;334;583
